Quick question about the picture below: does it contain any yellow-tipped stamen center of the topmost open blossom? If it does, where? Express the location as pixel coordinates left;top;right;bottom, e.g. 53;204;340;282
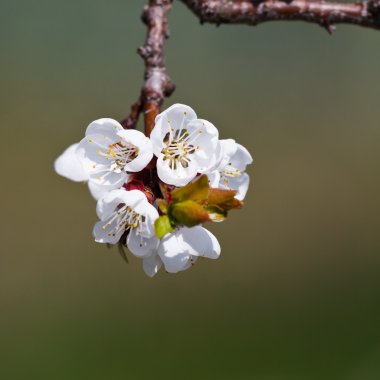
161;128;199;169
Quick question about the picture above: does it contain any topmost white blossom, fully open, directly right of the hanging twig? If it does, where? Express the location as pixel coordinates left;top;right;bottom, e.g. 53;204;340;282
150;104;221;186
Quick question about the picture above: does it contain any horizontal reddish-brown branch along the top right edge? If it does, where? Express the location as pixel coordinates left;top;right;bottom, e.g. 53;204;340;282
180;0;380;32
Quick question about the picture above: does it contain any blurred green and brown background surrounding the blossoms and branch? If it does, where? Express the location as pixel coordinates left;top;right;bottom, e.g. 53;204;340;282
0;0;380;380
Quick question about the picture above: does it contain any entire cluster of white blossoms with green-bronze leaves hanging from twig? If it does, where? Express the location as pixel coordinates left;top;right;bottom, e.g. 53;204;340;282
55;104;252;277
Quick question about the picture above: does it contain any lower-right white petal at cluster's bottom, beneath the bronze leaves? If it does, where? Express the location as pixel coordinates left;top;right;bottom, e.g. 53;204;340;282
180;226;220;259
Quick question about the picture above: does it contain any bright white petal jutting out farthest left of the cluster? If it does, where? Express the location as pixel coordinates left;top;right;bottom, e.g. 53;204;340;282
54;143;88;182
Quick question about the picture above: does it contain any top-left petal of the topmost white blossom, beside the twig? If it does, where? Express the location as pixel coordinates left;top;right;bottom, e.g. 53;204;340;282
150;104;197;157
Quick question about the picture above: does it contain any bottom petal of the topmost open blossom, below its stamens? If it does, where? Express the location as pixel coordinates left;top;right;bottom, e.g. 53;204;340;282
157;155;198;187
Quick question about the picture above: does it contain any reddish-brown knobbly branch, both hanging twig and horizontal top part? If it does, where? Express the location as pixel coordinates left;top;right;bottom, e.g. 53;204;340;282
122;0;380;136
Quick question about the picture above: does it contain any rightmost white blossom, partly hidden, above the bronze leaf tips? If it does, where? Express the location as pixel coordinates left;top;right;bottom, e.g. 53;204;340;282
207;139;253;200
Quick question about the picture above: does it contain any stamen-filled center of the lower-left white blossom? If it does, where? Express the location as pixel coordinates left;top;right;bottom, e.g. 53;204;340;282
102;203;146;236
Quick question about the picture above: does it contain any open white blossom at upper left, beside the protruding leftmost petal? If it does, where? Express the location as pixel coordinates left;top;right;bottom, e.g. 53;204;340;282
77;119;153;190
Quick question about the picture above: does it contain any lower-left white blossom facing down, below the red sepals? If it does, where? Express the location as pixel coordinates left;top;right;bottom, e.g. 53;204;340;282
93;189;158;257
